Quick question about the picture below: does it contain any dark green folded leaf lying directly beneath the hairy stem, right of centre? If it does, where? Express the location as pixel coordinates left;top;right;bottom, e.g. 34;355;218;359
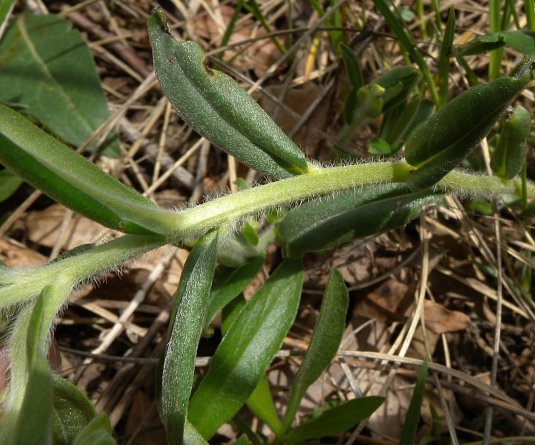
279;183;442;258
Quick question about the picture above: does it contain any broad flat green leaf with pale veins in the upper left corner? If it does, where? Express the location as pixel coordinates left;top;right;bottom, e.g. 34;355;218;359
0;14;118;154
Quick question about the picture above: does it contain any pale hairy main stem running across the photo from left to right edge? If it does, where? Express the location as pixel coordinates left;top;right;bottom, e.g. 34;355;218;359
0;161;535;310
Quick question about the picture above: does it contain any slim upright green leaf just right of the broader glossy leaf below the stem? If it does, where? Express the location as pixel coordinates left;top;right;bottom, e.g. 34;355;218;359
283;269;349;431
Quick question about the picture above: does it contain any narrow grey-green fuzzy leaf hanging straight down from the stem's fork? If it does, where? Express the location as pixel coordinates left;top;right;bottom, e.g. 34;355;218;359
161;231;218;444
